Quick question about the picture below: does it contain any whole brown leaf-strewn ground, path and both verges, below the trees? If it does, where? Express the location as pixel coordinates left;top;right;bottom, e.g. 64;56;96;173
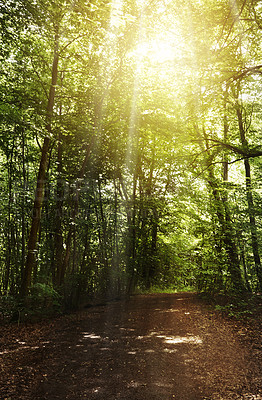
0;293;262;400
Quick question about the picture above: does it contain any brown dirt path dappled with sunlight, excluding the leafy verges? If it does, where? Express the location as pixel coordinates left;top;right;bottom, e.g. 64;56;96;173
0;293;262;400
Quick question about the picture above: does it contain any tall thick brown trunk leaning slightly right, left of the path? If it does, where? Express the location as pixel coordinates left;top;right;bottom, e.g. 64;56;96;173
20;32;59;297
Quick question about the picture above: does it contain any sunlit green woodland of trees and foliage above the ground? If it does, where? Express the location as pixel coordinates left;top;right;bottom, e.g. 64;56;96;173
0;0;262;307
